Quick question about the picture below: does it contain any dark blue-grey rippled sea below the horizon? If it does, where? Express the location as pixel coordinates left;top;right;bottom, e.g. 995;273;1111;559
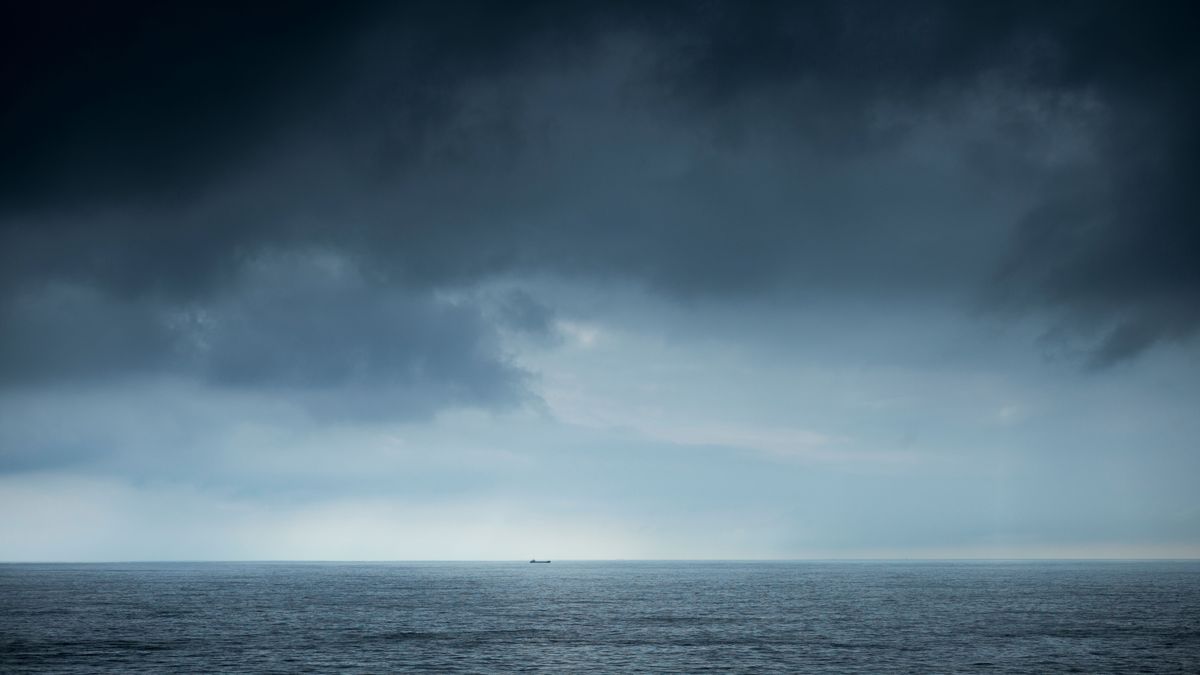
0;561;1200;673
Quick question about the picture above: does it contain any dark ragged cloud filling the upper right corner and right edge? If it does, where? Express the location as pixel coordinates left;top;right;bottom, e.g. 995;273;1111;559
648;2;1200;366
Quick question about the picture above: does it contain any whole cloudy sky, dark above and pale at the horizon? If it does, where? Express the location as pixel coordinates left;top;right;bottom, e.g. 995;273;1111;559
0;1;1200;561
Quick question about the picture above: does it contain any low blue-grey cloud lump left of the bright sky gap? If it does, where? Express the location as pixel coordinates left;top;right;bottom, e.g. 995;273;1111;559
194;256;522;414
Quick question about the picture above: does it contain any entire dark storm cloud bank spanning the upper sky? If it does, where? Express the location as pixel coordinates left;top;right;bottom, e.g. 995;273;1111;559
0;2;1200;396
